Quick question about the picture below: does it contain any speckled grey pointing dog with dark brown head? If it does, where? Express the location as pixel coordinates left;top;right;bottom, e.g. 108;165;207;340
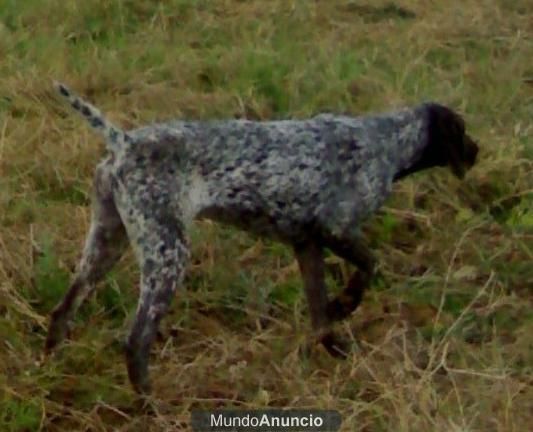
46;79;478;393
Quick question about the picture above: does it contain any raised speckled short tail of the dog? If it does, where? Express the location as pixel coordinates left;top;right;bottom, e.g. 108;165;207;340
54;81;131;153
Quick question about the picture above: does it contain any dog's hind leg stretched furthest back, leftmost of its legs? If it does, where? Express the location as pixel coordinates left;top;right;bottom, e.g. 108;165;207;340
45;164;127;351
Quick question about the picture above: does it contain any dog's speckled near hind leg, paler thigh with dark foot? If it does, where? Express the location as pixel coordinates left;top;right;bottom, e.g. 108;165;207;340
121;210;189;394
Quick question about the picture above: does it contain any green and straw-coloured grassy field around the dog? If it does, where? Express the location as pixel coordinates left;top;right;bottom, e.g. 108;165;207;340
0;0;533;432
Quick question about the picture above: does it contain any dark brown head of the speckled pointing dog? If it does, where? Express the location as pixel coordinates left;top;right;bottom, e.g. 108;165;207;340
422;103;479;179
